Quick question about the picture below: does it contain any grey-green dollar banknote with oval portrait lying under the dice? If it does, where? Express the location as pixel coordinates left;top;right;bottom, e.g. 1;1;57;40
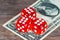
3;0;60;40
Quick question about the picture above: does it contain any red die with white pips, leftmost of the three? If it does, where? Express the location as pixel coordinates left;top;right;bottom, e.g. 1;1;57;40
16;17;30;32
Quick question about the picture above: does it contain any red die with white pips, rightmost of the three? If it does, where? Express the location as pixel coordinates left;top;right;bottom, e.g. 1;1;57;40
31;18;48;34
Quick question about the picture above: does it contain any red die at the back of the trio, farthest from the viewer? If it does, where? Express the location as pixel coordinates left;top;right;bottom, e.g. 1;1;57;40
21;7;36;19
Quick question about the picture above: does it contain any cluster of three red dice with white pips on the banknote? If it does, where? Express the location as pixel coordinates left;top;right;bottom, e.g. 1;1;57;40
16;7;48;35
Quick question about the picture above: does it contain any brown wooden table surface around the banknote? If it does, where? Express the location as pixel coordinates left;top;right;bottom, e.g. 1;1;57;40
0;0;60;40
